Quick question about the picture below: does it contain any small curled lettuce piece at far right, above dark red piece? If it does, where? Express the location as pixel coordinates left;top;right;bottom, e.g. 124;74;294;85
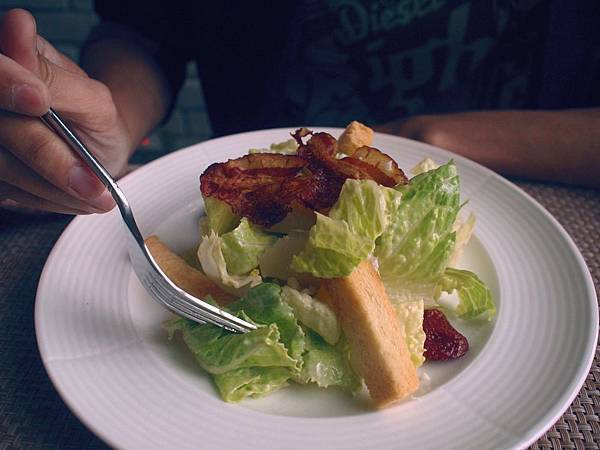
436;268;496;320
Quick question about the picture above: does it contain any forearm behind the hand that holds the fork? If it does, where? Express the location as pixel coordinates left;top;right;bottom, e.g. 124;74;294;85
81;37;173;154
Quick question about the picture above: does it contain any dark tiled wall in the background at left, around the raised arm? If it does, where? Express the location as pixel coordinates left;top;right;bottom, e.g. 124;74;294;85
0;0;211;162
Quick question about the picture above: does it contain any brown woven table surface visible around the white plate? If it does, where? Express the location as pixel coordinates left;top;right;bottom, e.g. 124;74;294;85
0;181;600;450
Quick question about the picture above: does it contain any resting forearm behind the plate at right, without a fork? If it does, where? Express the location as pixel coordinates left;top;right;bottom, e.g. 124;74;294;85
379;108;600;187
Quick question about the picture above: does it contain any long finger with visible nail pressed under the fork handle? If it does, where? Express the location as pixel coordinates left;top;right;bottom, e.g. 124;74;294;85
0;113;113;211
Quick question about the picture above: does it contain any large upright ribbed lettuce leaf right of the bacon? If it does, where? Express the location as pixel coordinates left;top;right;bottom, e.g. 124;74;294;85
375;161;460;302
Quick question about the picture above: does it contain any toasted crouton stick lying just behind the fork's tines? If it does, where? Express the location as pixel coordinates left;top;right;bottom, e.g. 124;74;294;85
144;236;236;305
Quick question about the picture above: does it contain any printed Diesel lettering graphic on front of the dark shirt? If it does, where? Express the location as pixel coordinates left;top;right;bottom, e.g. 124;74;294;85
285;0;552;125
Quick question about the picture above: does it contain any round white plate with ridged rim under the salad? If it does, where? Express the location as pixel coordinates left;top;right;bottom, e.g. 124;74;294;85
35;127;598;450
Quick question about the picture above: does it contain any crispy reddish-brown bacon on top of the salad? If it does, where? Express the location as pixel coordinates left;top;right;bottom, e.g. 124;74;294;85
200;128;407;227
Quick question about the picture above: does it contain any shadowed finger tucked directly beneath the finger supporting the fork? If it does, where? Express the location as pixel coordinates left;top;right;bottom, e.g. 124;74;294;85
0;148;113;212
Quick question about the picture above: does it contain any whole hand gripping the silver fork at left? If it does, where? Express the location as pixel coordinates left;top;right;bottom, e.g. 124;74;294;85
0;10;134;214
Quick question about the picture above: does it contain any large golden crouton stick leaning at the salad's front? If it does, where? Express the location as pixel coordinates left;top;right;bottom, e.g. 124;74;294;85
319;260;419;408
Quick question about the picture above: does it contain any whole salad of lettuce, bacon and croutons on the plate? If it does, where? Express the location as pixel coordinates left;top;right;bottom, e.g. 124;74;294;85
152;122;495;407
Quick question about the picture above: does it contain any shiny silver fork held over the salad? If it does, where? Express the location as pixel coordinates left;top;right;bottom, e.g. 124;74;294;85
41;108;256;333
